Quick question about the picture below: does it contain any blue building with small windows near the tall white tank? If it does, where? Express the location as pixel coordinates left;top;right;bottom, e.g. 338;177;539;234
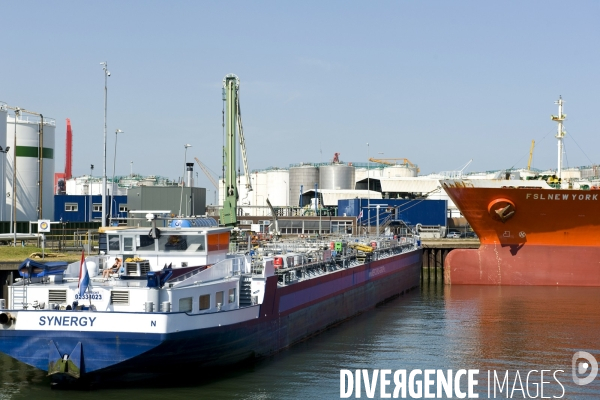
54;195;128;224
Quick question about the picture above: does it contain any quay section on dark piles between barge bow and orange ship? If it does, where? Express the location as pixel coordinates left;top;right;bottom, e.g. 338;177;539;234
421;238;479;283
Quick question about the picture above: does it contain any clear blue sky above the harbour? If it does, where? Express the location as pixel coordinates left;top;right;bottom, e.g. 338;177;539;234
0;1;600;188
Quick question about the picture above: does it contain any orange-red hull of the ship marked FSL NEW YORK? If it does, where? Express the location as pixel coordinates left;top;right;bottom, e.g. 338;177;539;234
442;181;600;286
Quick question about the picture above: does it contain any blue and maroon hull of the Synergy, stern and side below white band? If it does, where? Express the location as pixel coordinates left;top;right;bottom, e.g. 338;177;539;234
0;250;421;382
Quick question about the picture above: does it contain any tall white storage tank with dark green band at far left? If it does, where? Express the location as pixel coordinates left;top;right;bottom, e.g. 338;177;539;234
6;115;56;221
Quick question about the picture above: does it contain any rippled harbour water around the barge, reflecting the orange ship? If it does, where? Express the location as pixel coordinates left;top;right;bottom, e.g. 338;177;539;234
0;283;600;400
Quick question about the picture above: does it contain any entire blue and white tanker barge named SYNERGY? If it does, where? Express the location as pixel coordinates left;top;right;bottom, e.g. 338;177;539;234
0;214;421;381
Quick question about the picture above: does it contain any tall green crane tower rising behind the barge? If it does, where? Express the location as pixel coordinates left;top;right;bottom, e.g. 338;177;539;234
220;74;252;226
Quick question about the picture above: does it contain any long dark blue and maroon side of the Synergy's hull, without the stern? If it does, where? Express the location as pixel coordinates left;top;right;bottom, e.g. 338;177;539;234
110;251;421;374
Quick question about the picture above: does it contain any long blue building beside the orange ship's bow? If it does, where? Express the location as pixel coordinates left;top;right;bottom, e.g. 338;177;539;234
338;199;448;227
